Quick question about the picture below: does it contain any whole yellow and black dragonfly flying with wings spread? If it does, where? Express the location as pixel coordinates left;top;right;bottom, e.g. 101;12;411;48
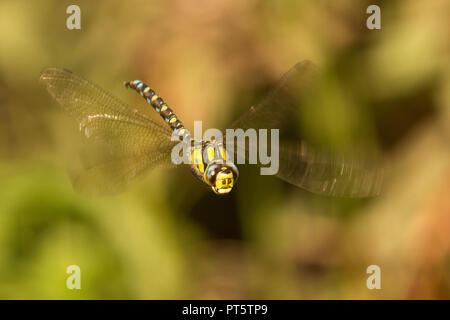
40;61;382;197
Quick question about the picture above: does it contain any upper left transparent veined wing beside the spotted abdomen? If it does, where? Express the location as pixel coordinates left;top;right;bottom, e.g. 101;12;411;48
40;68;172;152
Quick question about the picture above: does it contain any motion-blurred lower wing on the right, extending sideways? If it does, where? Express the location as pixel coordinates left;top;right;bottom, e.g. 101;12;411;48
277;142;383;197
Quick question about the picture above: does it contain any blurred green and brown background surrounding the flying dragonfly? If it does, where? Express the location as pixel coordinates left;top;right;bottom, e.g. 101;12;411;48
0;0;450;299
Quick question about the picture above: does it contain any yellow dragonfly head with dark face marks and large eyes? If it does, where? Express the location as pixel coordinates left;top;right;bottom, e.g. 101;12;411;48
203;162;239;194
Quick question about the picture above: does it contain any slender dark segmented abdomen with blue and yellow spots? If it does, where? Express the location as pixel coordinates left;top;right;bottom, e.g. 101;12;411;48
125;80;190;138
